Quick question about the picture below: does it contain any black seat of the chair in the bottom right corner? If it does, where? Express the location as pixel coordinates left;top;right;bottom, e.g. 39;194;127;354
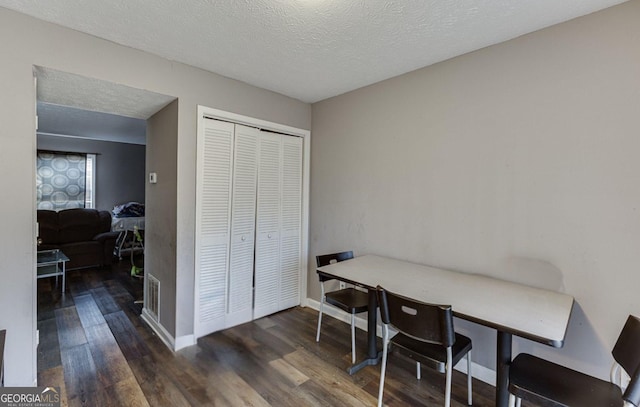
509;353;623;407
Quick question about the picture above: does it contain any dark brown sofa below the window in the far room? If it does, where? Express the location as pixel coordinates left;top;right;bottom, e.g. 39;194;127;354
38;209;119;270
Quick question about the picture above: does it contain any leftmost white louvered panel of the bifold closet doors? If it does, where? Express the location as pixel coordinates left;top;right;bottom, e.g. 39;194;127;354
195;119;234;337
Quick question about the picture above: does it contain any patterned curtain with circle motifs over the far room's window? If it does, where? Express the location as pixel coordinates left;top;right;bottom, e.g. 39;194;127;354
36;151;87;211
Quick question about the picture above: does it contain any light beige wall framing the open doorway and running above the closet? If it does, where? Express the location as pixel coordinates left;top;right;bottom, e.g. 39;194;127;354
0;8;311;386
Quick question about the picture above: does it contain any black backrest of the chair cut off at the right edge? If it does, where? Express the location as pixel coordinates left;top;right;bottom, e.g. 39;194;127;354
611;315;640;406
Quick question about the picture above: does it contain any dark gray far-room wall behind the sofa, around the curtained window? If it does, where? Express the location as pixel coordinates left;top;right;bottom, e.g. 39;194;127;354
37;134;145;211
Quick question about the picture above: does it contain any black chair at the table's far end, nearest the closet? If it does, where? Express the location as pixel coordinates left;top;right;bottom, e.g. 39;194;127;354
316;251;369;363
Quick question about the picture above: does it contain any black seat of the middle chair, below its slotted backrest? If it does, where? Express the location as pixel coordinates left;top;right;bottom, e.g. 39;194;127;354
391;333;471;373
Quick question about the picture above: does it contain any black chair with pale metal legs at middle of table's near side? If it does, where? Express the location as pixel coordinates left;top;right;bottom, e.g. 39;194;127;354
377;286;472;407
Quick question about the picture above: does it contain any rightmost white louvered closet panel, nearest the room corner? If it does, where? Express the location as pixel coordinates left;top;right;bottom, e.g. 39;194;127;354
279;136;302;310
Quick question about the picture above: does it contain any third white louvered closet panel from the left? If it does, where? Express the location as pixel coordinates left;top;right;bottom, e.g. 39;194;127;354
253;132;282;319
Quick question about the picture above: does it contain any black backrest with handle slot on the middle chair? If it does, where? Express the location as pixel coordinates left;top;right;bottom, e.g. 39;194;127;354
377;286;456;347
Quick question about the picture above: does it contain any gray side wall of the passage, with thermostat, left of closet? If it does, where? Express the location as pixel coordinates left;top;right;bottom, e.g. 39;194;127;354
144;100;178;334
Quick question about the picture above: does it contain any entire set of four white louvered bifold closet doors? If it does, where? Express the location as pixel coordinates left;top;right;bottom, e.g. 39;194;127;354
195;115;303;337
